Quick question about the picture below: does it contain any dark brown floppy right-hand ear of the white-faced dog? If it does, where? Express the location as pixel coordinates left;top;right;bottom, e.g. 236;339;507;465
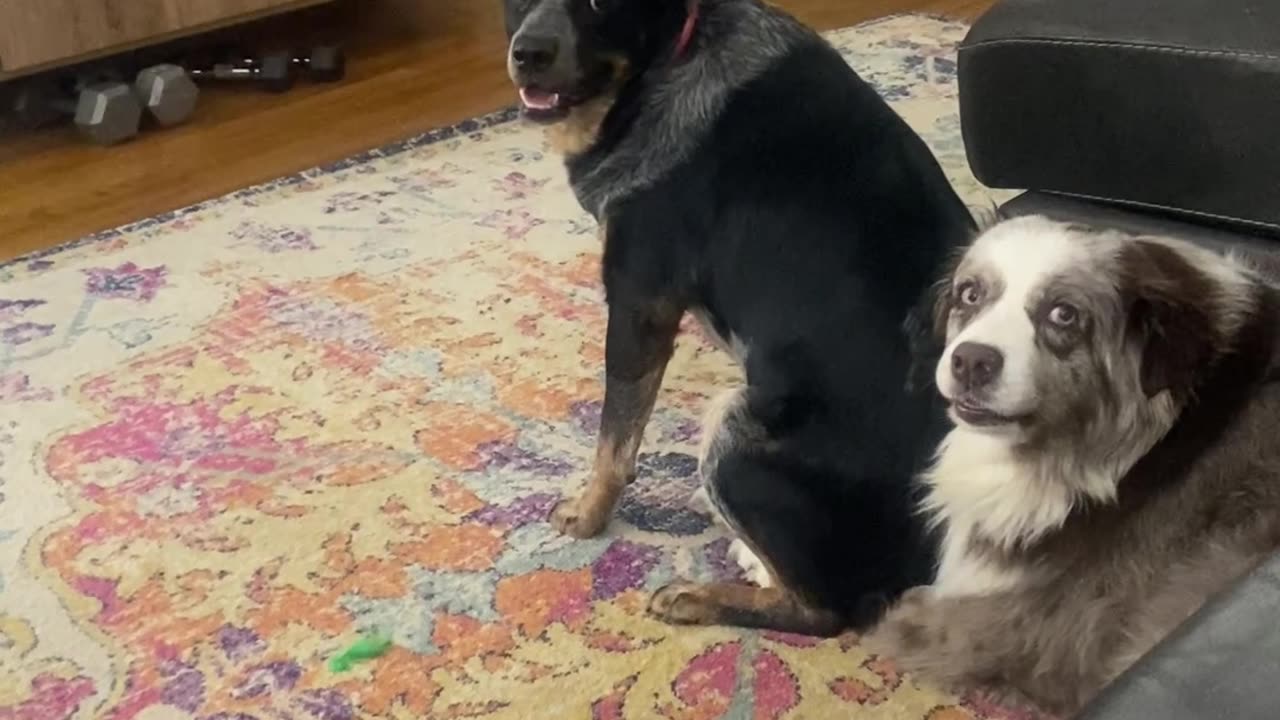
1119;240;1225;398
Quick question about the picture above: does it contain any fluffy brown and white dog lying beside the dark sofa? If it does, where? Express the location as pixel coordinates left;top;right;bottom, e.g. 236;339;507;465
865;217;1280;715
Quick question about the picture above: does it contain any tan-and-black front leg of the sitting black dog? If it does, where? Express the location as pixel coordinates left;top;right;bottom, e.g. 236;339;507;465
552;294;684;538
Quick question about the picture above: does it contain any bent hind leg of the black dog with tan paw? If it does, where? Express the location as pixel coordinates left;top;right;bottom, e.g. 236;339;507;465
649;425;933;635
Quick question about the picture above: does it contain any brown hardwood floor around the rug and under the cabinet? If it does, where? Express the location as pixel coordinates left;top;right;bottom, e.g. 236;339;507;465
0;0;992;260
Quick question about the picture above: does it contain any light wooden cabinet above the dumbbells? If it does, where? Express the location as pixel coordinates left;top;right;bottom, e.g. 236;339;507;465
0;0;335;74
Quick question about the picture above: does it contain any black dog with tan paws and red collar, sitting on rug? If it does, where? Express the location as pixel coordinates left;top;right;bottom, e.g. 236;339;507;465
506;0;974;634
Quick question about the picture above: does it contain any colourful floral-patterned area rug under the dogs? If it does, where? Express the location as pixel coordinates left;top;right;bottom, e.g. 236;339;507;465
0;15;1015;720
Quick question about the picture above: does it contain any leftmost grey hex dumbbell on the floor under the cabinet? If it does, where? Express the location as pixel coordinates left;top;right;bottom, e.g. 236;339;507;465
12;79;142;145
